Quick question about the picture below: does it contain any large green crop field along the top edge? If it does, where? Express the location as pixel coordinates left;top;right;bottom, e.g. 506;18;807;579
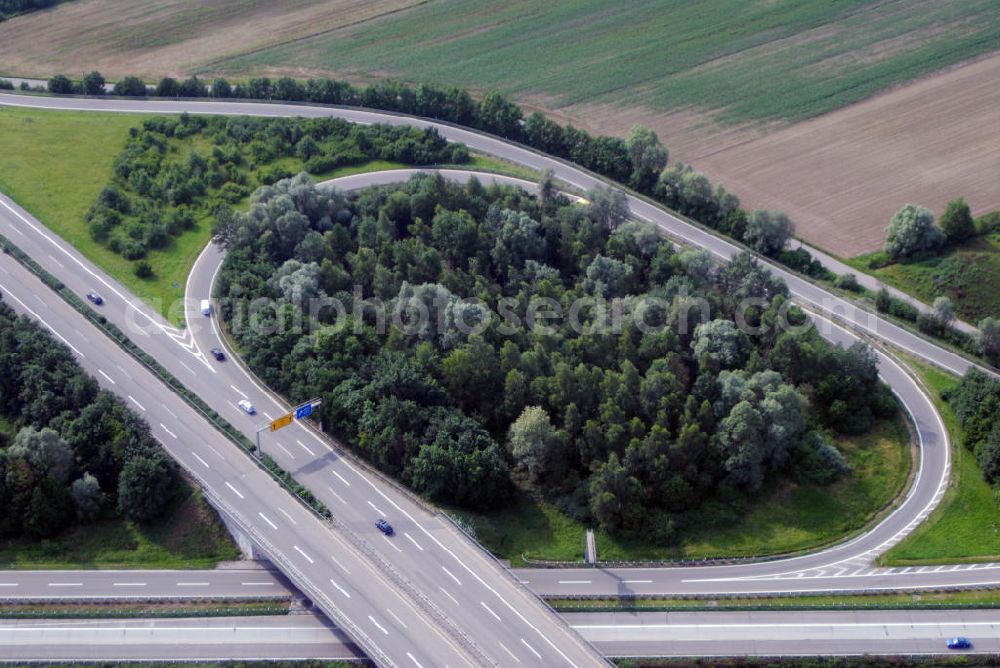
215;0;1000;121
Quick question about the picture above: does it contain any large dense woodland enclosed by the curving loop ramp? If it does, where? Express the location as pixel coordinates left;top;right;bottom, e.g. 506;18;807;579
217;174;895;542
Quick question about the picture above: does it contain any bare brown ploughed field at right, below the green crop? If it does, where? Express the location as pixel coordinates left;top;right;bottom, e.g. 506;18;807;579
564;49;1000;257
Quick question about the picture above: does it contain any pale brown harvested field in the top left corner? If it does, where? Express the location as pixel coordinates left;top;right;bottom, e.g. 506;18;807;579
0;0;424;80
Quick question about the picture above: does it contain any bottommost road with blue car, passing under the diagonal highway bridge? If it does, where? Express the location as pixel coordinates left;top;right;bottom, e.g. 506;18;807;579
0;610;1000;661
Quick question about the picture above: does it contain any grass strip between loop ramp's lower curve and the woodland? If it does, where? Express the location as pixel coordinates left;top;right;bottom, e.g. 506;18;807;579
456;417;911;566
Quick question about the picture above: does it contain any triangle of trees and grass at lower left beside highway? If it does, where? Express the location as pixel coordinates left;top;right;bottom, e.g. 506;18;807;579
0;302;238;568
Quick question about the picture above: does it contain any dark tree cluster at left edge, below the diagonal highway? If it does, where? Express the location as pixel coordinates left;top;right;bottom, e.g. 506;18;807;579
0;303;177;537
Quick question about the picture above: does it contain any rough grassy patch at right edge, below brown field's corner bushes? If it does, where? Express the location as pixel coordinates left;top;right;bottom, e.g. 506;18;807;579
846;233;1000;324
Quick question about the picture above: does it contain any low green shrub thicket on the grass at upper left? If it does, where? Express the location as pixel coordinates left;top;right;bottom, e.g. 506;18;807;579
87;115;468;266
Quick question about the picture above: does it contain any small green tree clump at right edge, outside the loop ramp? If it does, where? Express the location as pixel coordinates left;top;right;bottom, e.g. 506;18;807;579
945;368;1000;484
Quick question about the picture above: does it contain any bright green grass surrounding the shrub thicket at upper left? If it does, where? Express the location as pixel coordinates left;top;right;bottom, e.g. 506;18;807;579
0;108;536;324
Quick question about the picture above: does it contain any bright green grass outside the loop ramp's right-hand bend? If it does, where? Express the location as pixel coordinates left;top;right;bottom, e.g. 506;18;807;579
881;360;1000;566
